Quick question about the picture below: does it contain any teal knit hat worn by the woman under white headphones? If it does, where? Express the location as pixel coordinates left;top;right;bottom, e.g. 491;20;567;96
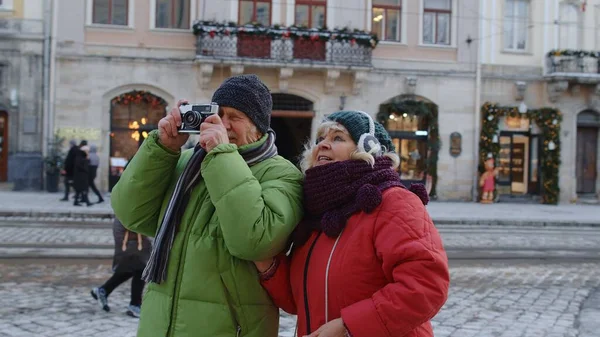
326;111;395;152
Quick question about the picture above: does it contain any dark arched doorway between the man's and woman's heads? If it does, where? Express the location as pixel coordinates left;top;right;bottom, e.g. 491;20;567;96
271;93;315;165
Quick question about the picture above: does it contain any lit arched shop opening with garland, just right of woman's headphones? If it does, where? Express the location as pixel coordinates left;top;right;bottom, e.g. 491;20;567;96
377;95;440;198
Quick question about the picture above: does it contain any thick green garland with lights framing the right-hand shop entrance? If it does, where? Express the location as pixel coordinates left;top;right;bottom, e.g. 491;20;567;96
479;102;562;205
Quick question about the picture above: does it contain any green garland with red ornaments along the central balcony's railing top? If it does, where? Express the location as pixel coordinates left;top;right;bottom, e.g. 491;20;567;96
193;21;379;49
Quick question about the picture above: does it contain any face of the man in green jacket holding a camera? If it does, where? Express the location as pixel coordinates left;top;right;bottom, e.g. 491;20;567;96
219;106;262;146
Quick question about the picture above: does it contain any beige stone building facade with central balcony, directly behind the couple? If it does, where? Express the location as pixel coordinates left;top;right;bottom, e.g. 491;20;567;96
53;0;480;200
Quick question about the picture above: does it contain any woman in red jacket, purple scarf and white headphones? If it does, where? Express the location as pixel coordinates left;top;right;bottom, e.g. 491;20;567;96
255;111;449;337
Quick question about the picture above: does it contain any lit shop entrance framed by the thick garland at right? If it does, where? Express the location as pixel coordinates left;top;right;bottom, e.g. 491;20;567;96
497;131;540;196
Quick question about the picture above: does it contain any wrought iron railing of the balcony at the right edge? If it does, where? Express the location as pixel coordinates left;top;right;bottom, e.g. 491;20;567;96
546;50;600;75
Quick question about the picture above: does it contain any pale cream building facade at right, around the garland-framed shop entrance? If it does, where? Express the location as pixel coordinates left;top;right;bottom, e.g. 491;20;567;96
480;0;600;203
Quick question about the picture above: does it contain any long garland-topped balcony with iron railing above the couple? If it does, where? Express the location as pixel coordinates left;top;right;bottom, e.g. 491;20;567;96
194;21;378;69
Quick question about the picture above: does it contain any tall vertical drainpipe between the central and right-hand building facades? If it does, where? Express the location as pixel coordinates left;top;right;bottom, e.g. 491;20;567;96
471;0;487;202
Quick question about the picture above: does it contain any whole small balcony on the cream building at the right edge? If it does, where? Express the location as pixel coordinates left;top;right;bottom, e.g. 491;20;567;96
546;50;600;83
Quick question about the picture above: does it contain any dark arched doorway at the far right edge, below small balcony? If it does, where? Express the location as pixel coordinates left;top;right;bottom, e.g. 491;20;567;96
576;110;600;195
